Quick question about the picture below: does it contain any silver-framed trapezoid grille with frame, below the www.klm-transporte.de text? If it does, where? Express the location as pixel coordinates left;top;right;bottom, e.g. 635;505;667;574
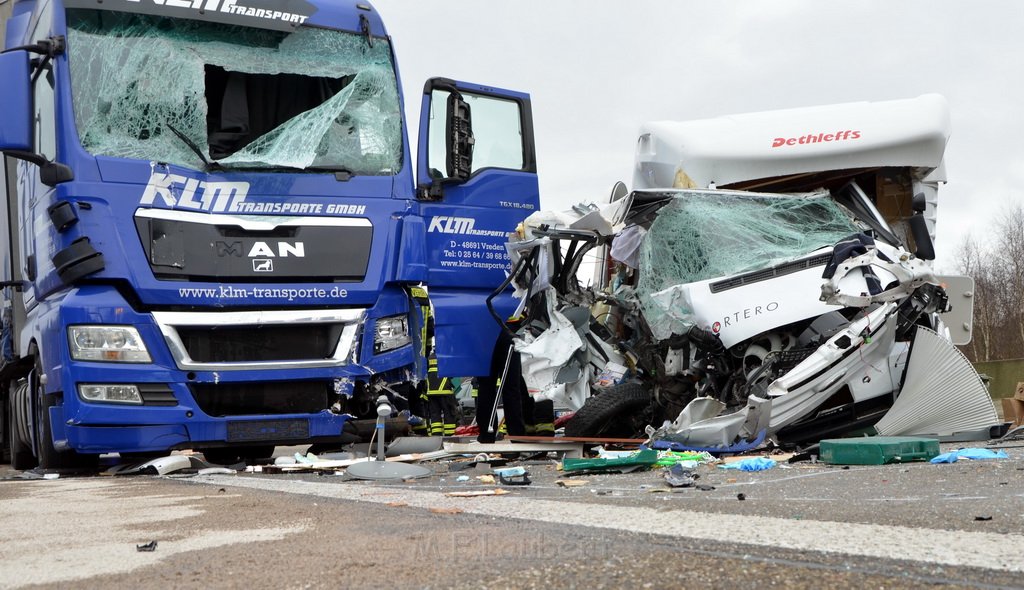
153;309;364;371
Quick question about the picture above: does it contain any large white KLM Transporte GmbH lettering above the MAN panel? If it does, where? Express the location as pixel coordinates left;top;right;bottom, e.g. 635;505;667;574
139;172;367;215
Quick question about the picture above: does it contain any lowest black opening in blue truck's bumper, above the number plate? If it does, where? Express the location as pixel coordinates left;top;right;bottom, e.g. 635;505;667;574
188;381;334;417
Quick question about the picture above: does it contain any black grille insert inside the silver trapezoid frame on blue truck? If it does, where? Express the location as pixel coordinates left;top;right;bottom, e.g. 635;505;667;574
177;324;344;363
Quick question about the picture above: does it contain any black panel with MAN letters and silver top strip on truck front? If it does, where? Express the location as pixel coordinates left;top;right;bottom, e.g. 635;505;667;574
135;209;373;283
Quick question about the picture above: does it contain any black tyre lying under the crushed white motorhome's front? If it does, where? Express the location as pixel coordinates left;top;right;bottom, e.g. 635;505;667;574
565;383;651;437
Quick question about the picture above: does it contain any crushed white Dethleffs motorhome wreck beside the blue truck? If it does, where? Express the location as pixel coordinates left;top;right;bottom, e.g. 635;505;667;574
508;94;998;451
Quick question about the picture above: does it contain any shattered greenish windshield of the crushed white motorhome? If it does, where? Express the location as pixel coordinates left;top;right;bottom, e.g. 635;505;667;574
637;191;858;338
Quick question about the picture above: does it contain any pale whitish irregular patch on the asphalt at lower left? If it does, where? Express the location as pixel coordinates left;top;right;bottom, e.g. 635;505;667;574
0;478;306;588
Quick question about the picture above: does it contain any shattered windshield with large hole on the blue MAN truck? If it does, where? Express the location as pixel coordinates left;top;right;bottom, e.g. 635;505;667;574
68;9;402;175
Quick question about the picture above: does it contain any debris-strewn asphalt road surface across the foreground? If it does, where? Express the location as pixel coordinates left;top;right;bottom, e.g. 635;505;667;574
0;446;1024;589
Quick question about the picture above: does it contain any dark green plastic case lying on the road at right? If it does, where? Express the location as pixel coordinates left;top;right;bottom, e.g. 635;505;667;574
819;436;939;465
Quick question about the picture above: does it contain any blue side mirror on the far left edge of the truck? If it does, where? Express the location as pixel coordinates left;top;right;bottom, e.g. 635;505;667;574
0;51;32;157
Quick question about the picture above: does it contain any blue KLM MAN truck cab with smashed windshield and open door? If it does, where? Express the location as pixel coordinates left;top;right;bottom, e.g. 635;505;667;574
0;0;539;469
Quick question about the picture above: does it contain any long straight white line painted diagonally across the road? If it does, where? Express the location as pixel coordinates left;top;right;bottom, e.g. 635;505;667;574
194;475;1024;572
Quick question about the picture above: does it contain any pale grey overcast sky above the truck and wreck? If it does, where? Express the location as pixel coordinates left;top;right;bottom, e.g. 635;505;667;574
373;0;1024;269
